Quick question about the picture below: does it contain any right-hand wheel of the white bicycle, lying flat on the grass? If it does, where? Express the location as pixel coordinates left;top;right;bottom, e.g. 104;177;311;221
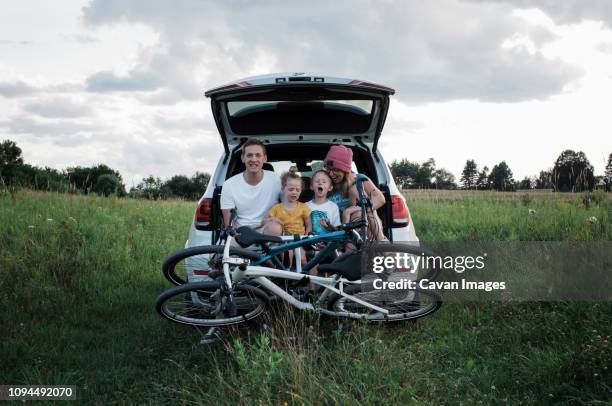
330;285;442;321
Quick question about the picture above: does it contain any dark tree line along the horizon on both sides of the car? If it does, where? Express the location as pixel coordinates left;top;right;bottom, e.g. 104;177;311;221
0;140;612;200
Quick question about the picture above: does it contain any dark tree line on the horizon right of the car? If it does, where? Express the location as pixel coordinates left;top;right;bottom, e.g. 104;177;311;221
389;150;612;192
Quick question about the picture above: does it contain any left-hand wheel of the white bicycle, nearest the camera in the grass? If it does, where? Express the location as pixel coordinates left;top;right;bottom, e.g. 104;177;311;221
155;280;268;327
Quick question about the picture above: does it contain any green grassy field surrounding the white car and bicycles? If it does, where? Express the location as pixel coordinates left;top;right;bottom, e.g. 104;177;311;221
0;191;612;405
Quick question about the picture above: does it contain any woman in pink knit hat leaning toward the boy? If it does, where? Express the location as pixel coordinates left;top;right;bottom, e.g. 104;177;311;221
323;145;387;241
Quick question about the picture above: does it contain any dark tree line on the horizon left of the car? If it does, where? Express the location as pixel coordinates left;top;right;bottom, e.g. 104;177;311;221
0;140;210;200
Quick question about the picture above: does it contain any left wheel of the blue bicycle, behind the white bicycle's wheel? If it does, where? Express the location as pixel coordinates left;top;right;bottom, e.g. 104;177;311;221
162;245;260;286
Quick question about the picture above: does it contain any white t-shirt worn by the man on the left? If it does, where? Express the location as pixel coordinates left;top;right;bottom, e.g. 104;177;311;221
221;171;281;226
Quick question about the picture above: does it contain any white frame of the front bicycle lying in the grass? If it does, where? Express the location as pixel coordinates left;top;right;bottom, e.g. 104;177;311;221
223;236;389;319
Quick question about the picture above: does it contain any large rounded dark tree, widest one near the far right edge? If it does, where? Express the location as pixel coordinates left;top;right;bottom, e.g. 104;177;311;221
553;149;595;192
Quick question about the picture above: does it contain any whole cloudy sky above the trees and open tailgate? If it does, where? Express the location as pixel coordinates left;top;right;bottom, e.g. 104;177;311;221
0;0;612;187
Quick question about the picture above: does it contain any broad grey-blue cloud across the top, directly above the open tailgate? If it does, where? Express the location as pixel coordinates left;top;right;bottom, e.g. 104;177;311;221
84;0;581;102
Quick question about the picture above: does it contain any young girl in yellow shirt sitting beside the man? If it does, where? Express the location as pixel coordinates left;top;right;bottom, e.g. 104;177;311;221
264;168;312;265
